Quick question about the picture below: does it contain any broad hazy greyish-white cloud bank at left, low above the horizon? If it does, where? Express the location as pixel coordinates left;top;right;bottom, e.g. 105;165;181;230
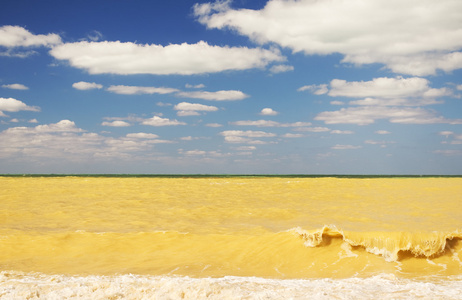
0;120;167;164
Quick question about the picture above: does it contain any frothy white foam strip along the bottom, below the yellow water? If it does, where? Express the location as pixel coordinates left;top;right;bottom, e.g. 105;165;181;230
0;272;462;300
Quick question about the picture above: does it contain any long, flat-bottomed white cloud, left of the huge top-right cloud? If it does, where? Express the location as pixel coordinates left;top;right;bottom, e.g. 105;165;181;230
50;41;285;75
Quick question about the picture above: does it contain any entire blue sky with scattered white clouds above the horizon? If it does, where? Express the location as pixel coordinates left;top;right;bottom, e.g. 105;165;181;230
0;0;462;175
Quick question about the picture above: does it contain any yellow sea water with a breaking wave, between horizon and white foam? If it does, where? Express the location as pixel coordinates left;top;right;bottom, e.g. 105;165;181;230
0;177;462;279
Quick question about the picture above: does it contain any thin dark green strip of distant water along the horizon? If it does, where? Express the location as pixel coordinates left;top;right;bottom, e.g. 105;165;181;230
0;174;462;178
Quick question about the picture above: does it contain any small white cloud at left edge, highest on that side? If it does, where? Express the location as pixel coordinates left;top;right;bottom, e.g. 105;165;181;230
0;25;61;48
